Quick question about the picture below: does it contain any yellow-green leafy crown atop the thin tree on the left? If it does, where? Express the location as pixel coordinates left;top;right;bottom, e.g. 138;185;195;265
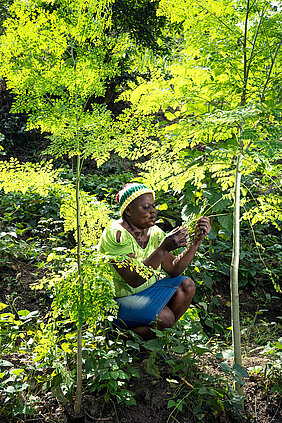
0;0;124;158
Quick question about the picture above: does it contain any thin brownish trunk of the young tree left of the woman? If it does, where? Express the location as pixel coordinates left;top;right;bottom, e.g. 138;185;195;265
74;154;83;414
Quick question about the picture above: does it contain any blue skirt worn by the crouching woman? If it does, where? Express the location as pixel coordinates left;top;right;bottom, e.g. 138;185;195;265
113;276;187;329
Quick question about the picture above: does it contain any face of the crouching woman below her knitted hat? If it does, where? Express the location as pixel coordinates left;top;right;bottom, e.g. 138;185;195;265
125;194;157;229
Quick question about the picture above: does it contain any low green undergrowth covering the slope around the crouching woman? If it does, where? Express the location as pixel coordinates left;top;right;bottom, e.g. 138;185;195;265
0;161;282;422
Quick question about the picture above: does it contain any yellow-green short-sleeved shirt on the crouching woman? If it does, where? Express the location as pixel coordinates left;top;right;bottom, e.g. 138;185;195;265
98;220;165;297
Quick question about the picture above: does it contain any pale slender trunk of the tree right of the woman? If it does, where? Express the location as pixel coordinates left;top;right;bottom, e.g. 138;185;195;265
230;153;243;393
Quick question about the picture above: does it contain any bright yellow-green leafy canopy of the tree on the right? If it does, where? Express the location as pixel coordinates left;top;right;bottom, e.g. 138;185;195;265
120;0;282;226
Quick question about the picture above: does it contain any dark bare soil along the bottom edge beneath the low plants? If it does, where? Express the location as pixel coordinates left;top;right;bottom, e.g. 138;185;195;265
32;357;282;423
